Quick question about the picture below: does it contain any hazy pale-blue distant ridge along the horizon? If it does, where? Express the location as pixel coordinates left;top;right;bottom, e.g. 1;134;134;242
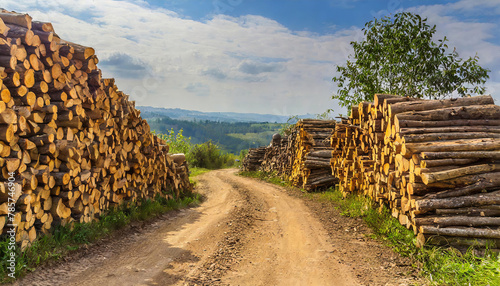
137;106;315;123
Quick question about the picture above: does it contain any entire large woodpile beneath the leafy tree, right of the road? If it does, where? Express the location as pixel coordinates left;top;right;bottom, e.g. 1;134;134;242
331;94;500;248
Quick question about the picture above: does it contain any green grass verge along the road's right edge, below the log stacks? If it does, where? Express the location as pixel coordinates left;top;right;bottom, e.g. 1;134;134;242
240;172;500;286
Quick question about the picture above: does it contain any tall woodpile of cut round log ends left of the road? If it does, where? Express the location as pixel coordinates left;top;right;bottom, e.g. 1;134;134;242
0;10;191;247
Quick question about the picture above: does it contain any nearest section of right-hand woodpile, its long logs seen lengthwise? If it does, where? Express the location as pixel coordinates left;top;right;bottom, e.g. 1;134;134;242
385;96;500;248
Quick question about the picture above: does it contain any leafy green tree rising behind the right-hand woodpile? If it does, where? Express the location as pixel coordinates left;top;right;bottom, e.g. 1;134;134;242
333;12;489;106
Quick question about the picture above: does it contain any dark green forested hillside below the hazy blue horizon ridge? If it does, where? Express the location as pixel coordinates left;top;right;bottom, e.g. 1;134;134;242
147;117;283;154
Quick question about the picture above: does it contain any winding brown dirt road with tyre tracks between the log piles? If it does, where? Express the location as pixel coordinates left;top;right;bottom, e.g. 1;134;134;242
17;170;413;286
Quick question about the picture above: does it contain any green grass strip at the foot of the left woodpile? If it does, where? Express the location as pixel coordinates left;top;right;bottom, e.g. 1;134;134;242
0;193;201;284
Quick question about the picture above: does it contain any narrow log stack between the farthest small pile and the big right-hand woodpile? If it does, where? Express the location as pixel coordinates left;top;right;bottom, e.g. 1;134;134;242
289;119;338;191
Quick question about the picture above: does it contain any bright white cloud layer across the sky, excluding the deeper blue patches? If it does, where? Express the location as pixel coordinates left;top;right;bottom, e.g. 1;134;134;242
0;0;500;114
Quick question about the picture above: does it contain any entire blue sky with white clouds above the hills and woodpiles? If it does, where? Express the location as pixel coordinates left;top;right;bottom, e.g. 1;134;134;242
0;0;500;115
